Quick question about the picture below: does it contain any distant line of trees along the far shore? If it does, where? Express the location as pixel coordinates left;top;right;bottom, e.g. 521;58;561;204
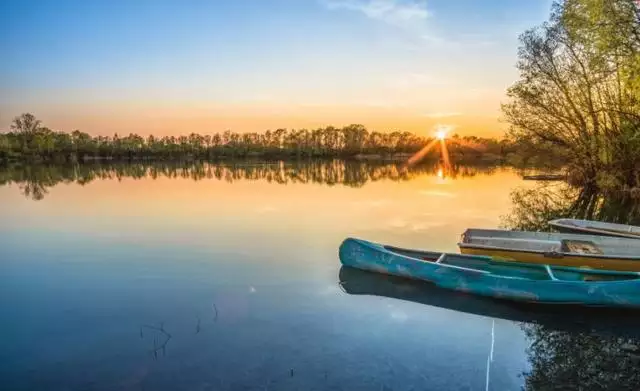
0;113;556;163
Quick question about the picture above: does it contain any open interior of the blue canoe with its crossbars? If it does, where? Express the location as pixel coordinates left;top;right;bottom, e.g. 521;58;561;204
385;246;640;282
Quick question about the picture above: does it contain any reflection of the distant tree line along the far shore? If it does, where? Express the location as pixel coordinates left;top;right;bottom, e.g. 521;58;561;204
0;160;495;200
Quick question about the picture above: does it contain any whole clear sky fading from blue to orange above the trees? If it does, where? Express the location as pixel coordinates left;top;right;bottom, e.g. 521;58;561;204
0;0;551;136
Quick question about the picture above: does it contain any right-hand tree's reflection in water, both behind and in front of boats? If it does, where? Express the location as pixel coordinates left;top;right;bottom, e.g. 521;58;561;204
503;183;640;390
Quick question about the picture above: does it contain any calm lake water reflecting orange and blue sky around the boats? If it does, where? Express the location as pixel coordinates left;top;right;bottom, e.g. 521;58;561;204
0;162;640;390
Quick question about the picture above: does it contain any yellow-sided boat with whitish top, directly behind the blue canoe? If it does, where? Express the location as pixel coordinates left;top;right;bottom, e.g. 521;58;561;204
458;228;640;271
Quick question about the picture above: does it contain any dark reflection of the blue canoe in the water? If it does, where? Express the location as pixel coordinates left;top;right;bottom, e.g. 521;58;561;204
339;266;640;338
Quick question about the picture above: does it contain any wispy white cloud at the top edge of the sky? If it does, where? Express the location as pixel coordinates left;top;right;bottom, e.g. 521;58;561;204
323;0;431;26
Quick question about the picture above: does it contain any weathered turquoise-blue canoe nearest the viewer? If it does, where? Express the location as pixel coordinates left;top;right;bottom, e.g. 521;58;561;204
339;238;640;308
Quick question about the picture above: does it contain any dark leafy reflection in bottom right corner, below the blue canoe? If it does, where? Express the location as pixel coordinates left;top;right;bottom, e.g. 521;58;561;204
522;323;640;391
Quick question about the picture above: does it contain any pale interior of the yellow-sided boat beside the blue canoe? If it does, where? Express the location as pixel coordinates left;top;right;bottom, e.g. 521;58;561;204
461;229;640;259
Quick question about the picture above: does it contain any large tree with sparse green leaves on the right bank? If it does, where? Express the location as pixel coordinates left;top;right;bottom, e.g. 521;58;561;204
503;0;640;193
